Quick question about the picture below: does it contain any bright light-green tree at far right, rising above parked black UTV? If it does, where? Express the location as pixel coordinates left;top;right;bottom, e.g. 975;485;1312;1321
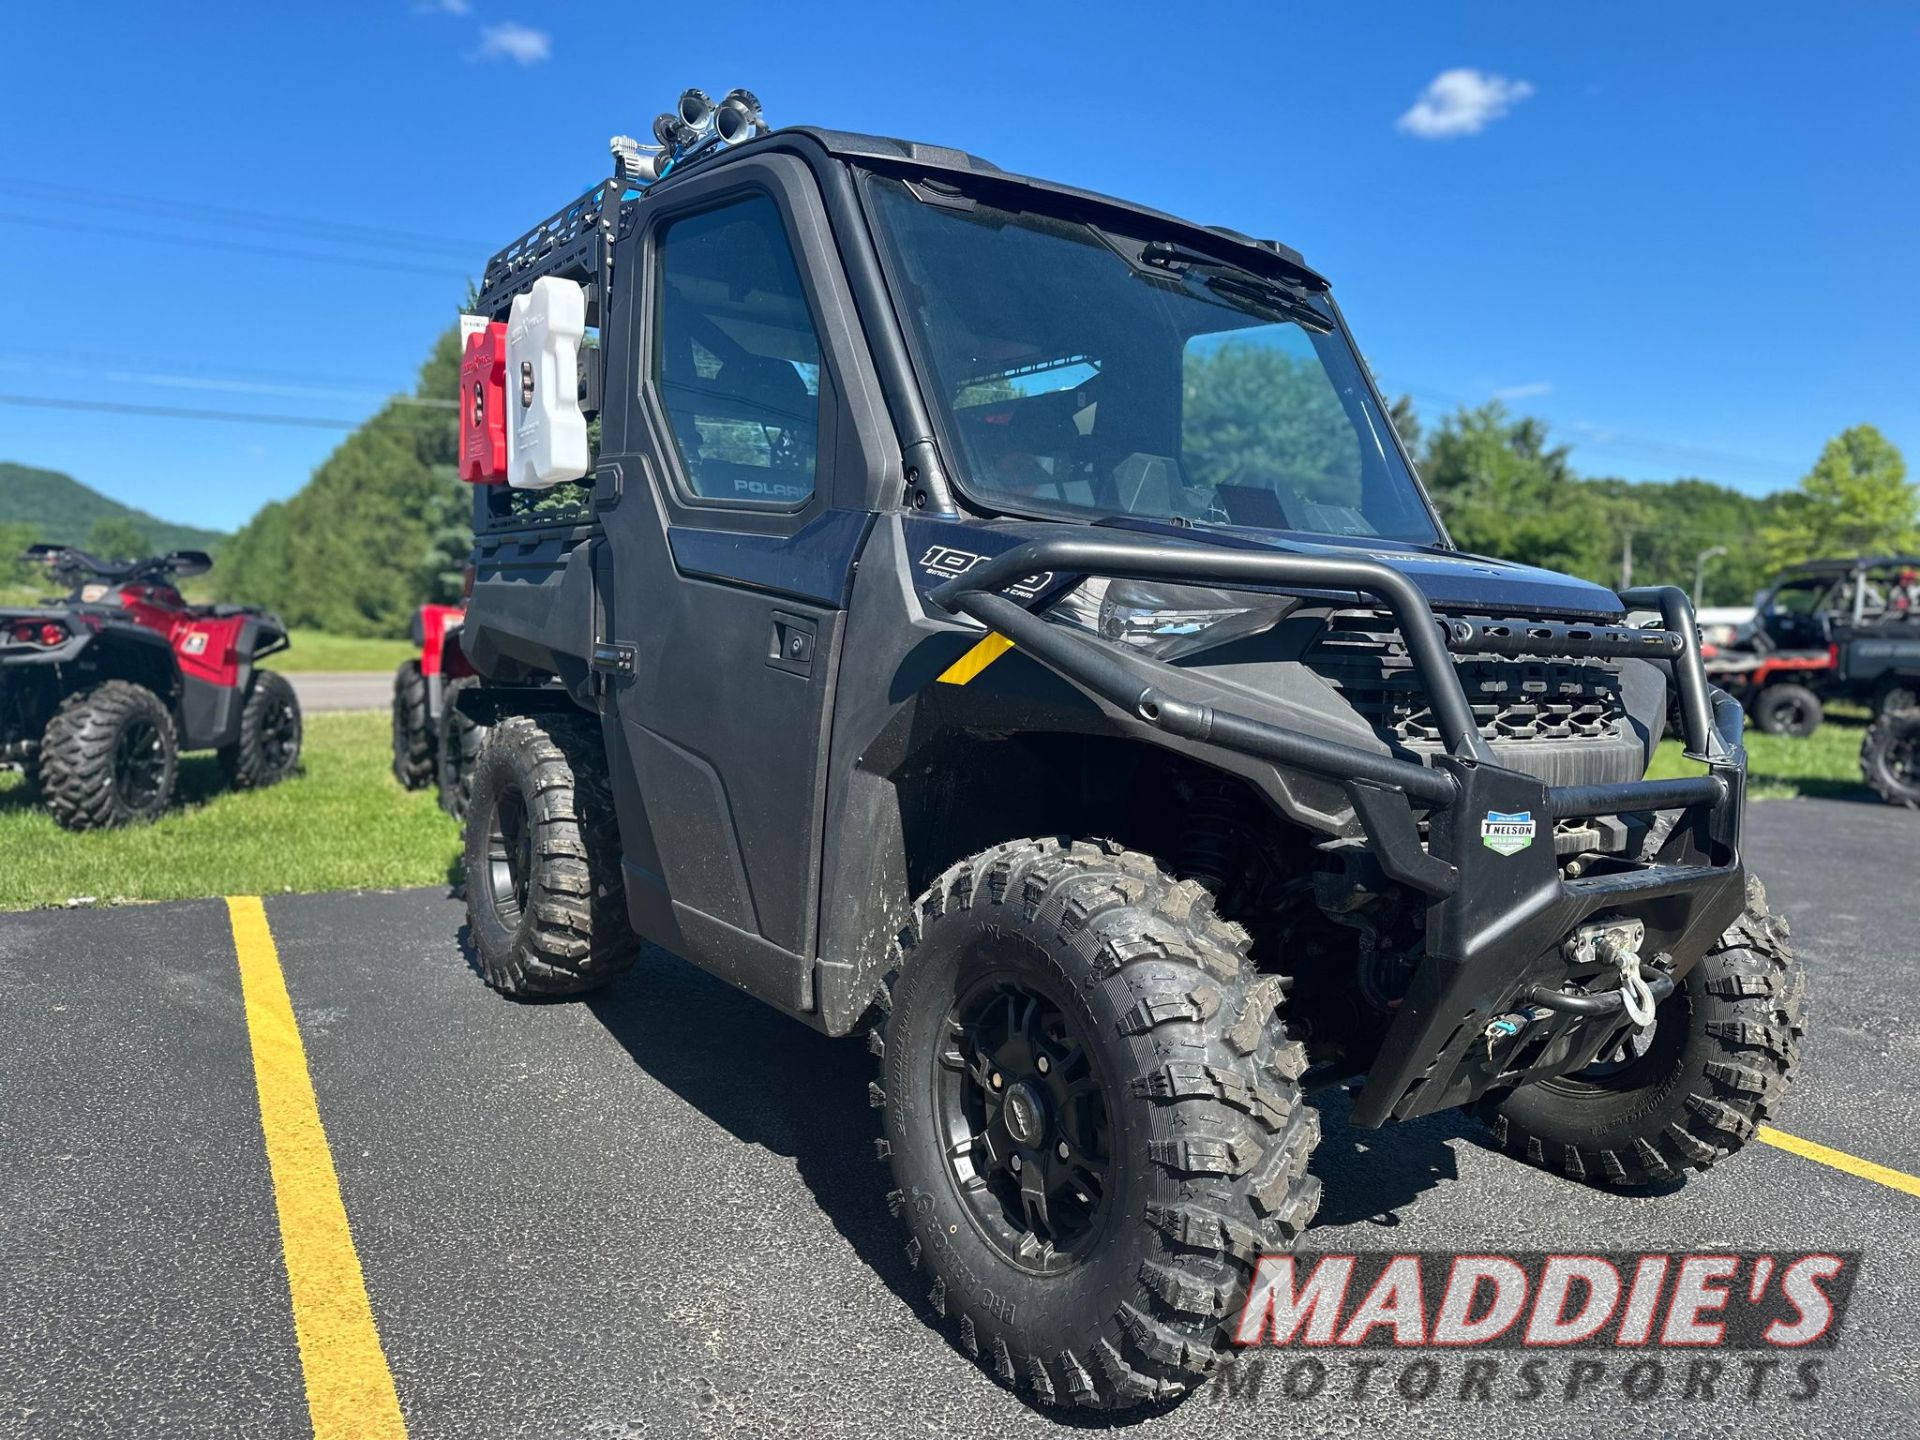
1766;424;1920;564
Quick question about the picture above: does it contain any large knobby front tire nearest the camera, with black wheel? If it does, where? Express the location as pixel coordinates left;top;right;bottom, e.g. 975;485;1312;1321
870;839;1319;1409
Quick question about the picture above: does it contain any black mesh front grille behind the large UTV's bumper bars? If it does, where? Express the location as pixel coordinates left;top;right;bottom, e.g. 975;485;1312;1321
1308;611;1626;749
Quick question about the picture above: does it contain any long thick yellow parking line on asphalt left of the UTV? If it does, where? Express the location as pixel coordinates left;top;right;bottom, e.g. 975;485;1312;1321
227;895;407;1440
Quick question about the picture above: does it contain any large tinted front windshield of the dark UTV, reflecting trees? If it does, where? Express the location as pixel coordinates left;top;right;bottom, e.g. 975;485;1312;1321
872;177;1440;545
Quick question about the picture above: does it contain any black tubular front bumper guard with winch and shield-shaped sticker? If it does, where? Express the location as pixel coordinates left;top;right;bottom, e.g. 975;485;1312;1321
931;538;1747;1125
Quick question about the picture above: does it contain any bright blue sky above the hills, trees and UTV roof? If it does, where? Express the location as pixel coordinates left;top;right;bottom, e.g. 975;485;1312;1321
0;0;1920;528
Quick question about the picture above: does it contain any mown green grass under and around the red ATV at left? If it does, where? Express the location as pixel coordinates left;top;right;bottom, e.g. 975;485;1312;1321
0;714;461;910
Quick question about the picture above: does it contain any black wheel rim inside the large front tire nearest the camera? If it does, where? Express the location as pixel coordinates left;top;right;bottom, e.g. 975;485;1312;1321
935;973;1114;1275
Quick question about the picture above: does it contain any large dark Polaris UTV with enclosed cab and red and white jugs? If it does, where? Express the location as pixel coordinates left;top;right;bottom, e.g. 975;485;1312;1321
459;96;1801;1407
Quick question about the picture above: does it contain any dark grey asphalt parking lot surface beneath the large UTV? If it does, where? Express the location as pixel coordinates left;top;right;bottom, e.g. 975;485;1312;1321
0;801;1920;1440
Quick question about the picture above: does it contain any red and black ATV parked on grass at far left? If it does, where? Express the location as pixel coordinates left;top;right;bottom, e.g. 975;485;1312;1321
0;545;300;829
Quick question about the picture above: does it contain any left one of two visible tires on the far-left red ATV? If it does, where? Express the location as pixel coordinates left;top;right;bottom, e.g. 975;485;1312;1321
38;680;180;829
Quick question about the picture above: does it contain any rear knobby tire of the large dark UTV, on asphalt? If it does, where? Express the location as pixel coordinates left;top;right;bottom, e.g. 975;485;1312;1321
467;714;639;996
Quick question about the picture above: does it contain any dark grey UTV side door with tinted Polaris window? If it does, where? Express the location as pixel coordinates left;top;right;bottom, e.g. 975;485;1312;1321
595;154;899;1012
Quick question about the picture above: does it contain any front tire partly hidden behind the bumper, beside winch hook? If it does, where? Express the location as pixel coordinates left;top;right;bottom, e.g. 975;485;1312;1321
1480;877;1805;1187
